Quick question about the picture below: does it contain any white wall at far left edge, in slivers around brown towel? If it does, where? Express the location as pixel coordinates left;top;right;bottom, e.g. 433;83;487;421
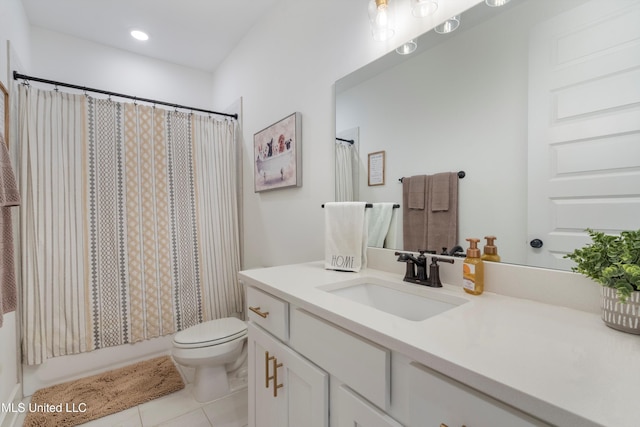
0;0;30;425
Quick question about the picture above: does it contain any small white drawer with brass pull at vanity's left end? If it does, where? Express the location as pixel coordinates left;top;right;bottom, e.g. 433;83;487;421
247;286;289;341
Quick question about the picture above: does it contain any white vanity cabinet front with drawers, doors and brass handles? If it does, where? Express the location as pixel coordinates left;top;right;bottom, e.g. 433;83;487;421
247;287;546;427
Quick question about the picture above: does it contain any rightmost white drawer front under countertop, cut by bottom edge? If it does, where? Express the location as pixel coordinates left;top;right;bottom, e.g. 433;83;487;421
409;362;547;427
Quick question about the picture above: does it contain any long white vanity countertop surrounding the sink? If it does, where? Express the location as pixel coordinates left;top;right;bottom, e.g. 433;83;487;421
240;262;640;427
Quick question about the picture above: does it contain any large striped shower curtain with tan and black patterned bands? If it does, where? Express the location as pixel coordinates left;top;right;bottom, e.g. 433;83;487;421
19;86;244;364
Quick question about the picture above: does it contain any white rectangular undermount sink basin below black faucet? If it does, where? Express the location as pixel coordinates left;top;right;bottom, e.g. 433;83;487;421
322;277;467;321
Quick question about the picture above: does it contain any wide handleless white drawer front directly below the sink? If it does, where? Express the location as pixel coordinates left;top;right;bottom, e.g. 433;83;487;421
289;309;391;411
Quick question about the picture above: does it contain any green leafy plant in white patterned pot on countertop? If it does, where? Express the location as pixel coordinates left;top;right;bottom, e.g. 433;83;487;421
565;229;640;334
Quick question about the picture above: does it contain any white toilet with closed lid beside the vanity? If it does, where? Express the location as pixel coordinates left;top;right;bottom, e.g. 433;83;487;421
172;317;247;402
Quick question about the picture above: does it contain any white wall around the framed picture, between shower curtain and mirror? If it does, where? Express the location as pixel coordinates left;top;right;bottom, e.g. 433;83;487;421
213;0;478;270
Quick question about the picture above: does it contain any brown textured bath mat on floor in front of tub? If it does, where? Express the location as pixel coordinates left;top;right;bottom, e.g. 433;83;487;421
23;356;184;427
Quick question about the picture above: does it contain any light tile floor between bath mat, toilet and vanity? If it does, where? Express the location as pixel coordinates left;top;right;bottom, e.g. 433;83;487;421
15;362;249;427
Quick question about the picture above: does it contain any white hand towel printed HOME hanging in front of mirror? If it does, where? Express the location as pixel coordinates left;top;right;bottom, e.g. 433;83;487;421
324;202;367;271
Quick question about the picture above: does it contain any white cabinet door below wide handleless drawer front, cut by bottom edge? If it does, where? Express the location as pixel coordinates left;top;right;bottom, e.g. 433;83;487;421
336;385;402;427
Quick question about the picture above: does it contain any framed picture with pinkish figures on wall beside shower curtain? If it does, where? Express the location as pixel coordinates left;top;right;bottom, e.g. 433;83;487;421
253;112;302;193
